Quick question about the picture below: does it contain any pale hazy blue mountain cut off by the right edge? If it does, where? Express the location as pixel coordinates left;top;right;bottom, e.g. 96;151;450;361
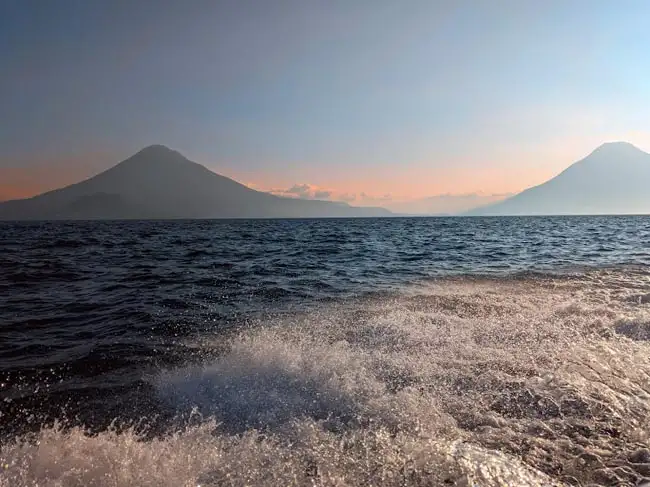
467;142;650;215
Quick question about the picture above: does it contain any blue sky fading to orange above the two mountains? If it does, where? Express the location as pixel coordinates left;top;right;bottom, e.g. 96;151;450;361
0;0;650;212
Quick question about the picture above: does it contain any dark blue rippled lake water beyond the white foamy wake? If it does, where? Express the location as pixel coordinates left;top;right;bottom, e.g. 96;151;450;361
0;217;650;433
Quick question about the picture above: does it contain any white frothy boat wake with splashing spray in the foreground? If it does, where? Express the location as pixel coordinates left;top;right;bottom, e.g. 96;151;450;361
0;270;650;487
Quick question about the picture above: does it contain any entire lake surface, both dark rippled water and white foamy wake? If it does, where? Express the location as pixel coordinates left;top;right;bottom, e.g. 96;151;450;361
0;217;650;486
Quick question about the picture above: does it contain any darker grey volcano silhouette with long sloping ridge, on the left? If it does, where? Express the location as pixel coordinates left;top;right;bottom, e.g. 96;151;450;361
0;145;391;220
